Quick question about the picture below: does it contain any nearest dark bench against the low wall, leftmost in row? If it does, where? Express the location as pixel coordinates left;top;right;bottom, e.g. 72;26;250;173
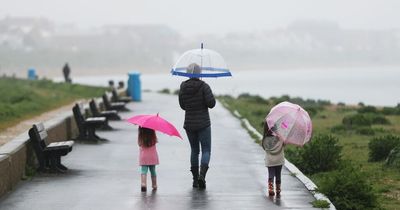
28;123;74;173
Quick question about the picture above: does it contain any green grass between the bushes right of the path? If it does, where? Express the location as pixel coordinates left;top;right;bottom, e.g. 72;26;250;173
218;96;400;209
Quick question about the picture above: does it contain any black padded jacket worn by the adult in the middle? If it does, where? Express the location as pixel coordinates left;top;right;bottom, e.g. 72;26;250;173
179;78;215;131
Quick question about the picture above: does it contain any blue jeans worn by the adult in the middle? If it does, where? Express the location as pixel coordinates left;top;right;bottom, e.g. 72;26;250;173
186;126;211;167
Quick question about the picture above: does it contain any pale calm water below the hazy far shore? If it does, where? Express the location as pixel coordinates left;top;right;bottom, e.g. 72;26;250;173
55;67;400;106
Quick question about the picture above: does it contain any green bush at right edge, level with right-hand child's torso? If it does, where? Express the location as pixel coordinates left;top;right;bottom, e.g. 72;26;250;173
368;135;400;161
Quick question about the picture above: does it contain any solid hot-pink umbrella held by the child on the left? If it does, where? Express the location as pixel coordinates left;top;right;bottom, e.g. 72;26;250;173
127;114;182;139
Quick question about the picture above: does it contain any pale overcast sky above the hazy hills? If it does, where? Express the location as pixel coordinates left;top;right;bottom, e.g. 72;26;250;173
0;0;400;35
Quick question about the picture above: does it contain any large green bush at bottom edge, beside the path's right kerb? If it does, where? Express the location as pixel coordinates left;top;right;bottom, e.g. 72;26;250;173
318;163;378;210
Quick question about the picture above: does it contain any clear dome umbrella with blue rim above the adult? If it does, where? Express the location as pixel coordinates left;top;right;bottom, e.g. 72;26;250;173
171;43;232;78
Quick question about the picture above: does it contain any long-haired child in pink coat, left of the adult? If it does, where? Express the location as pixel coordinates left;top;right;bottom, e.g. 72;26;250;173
138;126;159;192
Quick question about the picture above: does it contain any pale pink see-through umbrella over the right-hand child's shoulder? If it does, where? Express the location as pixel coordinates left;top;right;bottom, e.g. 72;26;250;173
265;101;312;146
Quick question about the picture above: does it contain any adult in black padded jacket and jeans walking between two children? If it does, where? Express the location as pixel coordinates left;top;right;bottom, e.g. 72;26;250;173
179;63;215;189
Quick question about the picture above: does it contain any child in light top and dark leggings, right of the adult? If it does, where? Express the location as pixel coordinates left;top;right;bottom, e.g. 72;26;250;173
262;122;285;197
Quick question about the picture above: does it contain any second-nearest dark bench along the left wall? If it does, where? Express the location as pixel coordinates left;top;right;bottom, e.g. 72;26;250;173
72;104;106;141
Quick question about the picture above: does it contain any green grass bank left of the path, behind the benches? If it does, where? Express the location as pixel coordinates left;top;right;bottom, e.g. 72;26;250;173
0;77;106;131
